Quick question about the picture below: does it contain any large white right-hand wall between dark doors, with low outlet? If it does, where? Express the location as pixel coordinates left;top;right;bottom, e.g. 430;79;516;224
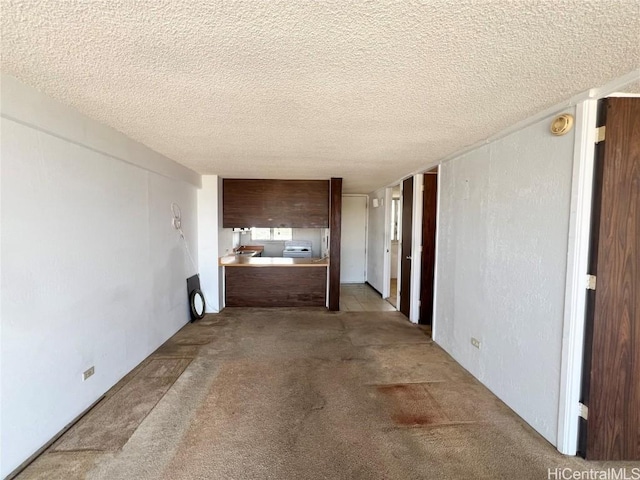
435;109;574;445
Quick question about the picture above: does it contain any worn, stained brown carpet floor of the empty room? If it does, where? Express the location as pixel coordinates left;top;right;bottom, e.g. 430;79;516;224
17;309;624;480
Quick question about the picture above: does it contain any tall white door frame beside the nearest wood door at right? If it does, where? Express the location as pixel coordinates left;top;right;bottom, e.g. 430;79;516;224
557;100;598;455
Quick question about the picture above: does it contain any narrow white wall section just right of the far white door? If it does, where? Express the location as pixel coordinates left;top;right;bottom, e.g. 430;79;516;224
367;188;388;293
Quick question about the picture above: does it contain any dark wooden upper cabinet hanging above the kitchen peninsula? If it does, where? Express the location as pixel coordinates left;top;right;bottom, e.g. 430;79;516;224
222;178;329;228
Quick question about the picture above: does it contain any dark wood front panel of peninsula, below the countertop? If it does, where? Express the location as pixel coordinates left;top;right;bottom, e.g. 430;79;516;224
225;267;327;307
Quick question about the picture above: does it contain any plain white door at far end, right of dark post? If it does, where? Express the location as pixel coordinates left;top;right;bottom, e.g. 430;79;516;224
340;195;369;283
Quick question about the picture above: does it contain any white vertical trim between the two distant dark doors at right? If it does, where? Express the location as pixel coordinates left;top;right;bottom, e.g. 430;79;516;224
409;173;424;323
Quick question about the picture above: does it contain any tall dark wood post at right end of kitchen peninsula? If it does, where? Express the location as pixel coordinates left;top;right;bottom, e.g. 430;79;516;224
329;178;342;312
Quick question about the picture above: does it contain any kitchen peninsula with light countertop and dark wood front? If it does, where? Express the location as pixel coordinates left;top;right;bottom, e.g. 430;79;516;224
219;255;329;307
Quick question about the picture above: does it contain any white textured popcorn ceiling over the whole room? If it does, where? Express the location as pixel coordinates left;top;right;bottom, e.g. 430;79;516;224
1;0;640;193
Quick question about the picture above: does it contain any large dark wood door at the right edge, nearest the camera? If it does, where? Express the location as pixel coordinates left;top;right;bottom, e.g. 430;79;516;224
587;98;640;460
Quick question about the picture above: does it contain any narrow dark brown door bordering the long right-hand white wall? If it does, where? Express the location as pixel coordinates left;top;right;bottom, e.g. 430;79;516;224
419;173;438;325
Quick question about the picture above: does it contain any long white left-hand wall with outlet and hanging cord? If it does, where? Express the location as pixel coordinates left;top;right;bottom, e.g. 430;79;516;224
0;75;199;477
